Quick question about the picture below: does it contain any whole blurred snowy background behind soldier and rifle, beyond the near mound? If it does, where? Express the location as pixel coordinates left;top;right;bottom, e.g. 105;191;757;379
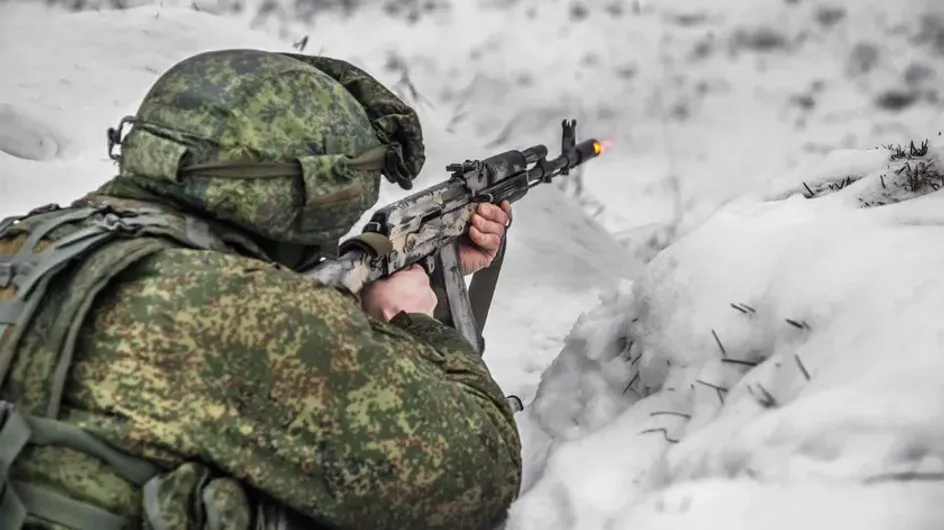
0;0;944;401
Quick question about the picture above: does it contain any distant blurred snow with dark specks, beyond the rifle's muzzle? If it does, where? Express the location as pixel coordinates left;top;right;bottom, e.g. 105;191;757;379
16;0;944;257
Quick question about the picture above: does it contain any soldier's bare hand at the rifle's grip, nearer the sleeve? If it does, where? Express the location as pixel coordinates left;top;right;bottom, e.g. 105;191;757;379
361;265;437;322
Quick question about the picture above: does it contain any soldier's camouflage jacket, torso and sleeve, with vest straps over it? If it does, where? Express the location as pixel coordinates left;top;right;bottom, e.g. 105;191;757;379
0;197;521;530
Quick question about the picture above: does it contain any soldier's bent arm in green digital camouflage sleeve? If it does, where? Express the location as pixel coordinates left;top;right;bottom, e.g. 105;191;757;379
69;250;521;529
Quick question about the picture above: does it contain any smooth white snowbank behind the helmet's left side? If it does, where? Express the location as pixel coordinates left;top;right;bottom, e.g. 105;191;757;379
0;3;286;207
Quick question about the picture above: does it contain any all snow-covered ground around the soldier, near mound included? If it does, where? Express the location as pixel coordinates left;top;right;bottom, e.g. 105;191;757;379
0;0;944;530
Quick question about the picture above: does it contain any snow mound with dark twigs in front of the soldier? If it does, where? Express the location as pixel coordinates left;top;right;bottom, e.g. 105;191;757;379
506;139;944;530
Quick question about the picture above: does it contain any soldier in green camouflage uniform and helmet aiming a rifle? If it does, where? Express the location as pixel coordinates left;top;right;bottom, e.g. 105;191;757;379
0;50;521;530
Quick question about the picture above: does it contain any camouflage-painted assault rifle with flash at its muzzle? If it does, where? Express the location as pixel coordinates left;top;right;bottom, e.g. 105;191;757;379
306;120;603;355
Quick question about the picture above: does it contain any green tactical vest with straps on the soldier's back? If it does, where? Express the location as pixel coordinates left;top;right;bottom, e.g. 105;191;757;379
0;197;276;530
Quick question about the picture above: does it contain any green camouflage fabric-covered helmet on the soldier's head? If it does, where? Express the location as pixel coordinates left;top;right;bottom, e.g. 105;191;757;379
109;50;425;253
